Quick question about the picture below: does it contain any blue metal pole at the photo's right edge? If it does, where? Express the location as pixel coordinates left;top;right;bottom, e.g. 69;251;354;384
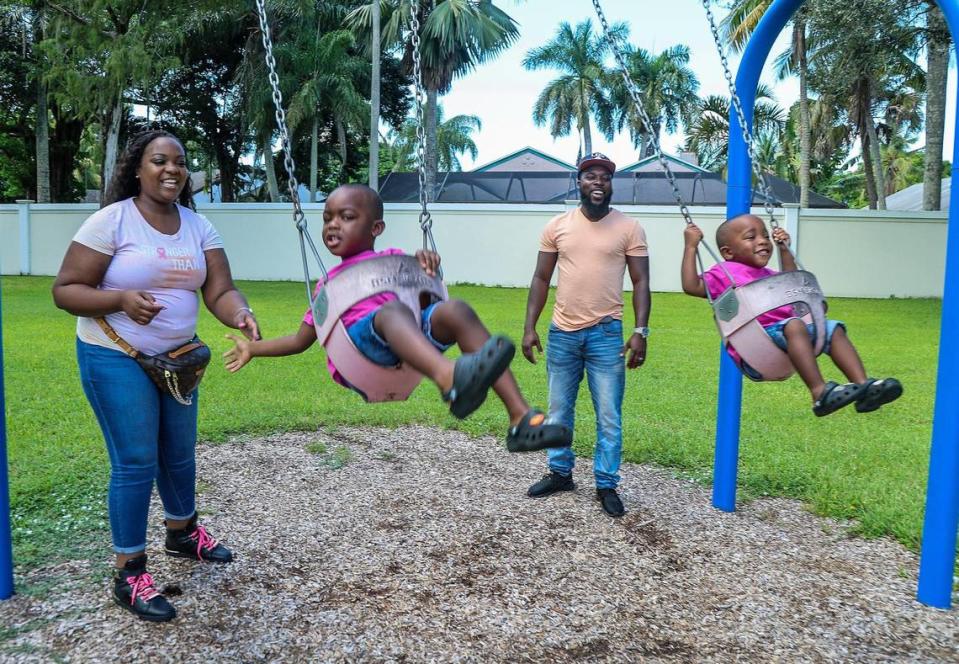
916;0;959;609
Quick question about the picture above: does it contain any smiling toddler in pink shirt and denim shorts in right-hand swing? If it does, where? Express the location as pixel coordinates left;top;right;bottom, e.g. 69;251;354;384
681;214;902;417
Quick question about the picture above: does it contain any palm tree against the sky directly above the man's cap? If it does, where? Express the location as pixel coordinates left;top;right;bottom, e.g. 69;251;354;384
523;19;629;154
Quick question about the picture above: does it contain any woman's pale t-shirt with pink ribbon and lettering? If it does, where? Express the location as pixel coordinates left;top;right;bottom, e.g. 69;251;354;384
73;198;223;355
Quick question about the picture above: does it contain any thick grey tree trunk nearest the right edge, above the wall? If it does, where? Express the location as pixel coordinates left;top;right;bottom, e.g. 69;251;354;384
922;0;950;210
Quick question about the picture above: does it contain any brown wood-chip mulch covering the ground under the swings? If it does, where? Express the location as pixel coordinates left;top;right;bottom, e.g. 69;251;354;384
0;427;959;662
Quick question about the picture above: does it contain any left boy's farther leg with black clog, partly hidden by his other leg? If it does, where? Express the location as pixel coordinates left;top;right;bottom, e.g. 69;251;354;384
430;300;572;452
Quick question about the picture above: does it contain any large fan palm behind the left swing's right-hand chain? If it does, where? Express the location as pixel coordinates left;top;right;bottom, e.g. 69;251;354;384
346;0;519;195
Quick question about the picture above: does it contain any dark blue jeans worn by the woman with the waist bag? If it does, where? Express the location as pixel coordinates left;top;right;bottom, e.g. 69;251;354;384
77;339;199;553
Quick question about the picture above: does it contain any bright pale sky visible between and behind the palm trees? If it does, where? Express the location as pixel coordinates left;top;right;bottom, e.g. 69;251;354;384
430;0;956;170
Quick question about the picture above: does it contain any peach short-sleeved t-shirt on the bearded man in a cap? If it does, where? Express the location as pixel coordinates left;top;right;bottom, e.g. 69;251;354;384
539;208;648;332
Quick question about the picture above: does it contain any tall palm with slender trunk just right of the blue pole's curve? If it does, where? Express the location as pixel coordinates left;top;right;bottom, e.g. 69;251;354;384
722;0;812;207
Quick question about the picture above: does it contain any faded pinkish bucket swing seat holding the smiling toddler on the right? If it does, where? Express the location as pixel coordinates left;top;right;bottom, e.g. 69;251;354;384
712;270;826;381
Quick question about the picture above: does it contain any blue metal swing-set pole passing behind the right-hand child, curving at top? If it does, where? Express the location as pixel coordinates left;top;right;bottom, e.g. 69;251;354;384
713;0;804;512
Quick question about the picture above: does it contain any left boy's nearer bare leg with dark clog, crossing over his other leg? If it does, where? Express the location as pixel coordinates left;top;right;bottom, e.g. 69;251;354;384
373;301;516;419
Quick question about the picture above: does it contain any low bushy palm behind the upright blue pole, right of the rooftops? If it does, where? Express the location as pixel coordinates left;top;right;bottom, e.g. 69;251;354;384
686;85;786;174
